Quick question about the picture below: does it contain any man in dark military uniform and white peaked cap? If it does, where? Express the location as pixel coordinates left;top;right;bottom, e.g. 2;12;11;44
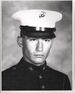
2;10;71;90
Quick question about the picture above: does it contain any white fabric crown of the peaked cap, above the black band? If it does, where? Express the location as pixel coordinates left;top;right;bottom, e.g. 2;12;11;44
12;9;62;28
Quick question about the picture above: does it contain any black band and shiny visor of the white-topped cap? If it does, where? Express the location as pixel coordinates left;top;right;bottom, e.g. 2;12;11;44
20;26;56;39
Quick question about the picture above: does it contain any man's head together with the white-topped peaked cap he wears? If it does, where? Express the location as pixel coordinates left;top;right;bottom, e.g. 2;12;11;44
13;10;62;66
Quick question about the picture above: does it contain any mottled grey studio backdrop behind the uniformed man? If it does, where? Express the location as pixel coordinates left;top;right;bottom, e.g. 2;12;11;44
2;1;72;86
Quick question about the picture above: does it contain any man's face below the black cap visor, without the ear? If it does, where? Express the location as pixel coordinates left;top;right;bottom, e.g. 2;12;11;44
18;36;52;65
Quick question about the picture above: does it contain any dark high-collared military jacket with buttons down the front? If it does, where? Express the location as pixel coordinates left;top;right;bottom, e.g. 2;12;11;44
2;58;71;90
